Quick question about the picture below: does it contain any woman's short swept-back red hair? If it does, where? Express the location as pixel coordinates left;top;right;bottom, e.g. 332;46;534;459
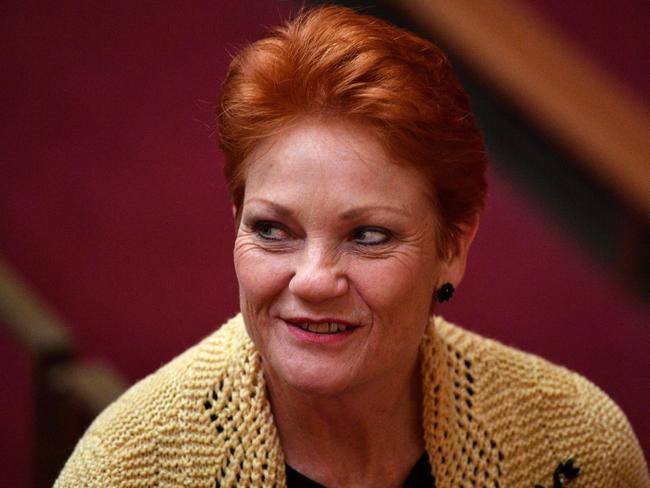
217;6;486;257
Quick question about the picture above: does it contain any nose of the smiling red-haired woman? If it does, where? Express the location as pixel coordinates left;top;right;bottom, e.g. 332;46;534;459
289;245;348;303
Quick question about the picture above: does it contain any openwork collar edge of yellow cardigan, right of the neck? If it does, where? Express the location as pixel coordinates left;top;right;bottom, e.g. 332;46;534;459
420;317;503;488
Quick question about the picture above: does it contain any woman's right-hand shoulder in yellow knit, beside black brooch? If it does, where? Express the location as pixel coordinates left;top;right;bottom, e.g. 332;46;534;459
426;317;650;487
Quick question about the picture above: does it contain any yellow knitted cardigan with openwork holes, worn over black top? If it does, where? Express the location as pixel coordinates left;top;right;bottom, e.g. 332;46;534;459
55;316;650;488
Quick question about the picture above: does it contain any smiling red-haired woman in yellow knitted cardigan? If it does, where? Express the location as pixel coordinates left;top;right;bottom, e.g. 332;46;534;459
57;7;650;487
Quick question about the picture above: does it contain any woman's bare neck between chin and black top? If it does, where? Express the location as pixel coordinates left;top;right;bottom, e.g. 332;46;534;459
266;352;424;486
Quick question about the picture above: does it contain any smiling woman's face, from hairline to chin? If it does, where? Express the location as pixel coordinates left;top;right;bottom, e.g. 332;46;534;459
234;122;460;395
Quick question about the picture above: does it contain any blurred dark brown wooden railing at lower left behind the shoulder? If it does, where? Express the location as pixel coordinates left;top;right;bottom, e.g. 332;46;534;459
0;260;126;488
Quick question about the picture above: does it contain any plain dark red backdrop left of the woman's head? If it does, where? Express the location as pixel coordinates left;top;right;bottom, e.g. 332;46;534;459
0;0;290;486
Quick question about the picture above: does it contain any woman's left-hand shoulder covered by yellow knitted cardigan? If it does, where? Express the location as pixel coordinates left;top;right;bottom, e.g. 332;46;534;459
56;317;250;486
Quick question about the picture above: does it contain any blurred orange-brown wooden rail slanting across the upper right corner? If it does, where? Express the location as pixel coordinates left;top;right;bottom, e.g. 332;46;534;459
388;0;650;218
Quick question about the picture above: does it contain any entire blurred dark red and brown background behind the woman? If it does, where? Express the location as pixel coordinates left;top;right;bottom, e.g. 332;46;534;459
0;0;650;487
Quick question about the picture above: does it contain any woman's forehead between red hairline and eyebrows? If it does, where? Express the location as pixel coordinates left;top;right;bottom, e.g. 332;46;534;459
245;121;430;206
